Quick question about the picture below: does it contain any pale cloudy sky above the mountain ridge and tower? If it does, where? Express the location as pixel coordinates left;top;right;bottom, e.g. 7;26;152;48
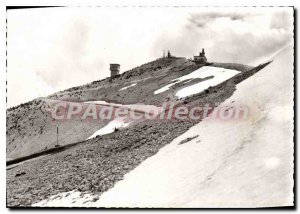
7;7;293;108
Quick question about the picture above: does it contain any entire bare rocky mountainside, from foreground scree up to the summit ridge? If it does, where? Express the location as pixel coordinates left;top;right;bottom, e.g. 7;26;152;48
7;55;268;206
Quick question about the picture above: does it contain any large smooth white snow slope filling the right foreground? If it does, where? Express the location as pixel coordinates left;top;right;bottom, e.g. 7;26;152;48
90;47;293;207
